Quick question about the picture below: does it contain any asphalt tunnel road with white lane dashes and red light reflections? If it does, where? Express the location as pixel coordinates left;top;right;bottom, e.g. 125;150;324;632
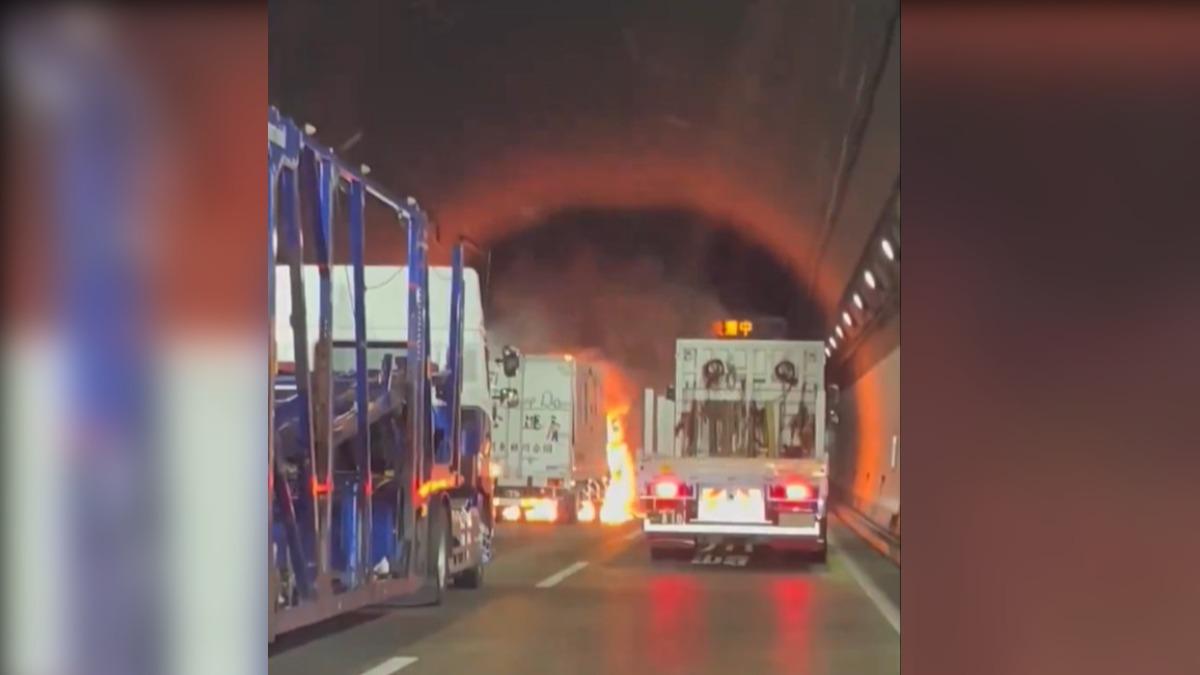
269;516;900;675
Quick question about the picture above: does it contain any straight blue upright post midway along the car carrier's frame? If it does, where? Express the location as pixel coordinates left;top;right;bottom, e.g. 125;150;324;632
349;180;372;579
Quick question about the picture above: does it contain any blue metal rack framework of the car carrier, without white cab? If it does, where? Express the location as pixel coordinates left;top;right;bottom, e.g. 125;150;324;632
268;108;463;639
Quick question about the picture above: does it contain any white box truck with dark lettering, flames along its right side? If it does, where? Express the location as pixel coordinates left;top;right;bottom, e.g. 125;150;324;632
492;356;608;522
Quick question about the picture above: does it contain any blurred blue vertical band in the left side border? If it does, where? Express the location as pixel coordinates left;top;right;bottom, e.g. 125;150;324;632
54;55;164;675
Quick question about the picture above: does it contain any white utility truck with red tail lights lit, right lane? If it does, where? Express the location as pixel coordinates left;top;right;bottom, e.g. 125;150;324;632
637;339;829;561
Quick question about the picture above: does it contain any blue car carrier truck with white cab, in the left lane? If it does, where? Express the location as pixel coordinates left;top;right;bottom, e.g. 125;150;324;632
266;108;520;640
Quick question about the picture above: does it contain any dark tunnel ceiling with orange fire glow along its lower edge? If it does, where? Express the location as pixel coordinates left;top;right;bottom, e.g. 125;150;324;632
270;0;898;307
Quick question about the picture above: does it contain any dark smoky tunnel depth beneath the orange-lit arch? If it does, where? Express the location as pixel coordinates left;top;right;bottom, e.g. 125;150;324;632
485;207;821;389
